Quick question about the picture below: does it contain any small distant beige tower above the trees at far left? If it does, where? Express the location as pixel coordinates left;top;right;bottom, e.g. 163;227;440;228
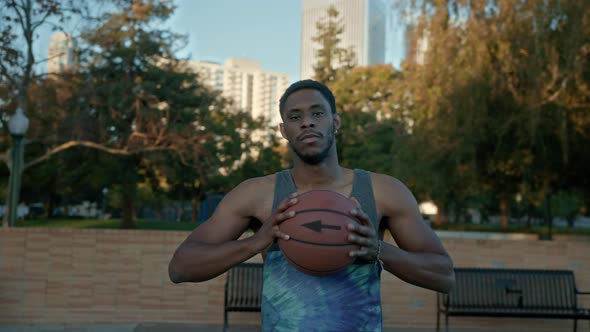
47;32;78;74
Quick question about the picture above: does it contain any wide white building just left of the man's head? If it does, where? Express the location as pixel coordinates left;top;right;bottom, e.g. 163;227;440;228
189;58;289;126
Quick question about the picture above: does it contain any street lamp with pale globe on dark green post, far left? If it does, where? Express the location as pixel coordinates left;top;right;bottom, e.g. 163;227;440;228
8;107;29;227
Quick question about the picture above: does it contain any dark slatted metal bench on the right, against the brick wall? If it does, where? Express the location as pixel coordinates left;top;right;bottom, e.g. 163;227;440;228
436;268;590;331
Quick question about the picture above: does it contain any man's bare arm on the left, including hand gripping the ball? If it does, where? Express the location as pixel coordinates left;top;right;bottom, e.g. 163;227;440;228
168;179;294;283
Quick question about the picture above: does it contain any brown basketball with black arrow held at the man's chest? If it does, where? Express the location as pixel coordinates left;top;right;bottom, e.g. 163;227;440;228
278;190;359;275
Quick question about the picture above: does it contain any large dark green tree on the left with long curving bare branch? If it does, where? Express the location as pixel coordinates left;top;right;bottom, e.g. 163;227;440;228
0;0;284;227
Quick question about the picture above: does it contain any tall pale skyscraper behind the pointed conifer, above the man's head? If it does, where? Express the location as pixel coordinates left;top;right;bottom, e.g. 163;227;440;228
300;0;386;79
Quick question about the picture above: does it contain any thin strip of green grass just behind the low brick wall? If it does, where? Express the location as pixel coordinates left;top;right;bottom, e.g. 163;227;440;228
16;219;590;235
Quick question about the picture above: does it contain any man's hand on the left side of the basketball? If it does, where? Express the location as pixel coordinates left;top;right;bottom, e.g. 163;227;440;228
253;193;298;253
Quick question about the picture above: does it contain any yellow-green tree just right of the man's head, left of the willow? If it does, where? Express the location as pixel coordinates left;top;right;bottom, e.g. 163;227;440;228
329;65;412;174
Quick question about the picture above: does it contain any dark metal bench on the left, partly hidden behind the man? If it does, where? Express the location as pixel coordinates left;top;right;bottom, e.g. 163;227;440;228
223;263;263;331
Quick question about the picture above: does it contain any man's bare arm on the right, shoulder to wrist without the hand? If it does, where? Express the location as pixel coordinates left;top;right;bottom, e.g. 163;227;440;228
373;175;455;292
